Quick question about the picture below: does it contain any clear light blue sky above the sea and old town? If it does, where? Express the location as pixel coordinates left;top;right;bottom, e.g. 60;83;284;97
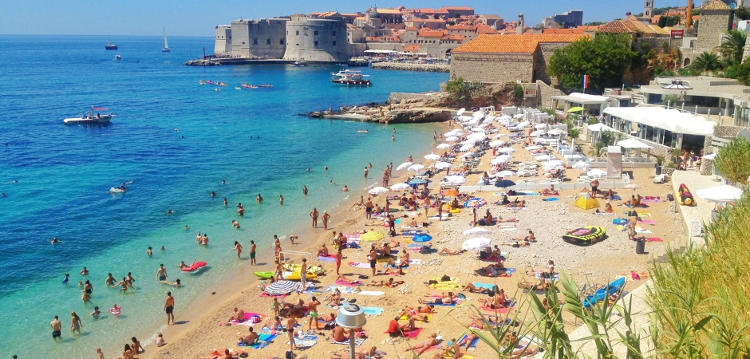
0;0;700;36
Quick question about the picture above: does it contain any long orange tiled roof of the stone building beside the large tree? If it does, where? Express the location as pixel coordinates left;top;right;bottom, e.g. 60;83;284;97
453;34;589;54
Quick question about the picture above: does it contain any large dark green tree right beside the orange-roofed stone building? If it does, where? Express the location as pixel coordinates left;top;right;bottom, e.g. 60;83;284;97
548;34;636;91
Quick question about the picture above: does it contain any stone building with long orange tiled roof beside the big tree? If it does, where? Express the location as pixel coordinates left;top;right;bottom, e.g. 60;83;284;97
450;34;589;83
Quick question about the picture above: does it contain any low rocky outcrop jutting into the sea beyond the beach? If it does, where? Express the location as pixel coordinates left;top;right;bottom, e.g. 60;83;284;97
307;92;456;123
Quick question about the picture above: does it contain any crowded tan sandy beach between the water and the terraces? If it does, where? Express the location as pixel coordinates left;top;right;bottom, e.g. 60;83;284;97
139;111;685;358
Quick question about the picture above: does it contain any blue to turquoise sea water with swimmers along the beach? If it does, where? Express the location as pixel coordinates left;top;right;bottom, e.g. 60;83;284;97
0;36;447;358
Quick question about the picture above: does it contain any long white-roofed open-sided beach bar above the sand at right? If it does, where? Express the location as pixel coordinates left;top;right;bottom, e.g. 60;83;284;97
603;107;716;152
